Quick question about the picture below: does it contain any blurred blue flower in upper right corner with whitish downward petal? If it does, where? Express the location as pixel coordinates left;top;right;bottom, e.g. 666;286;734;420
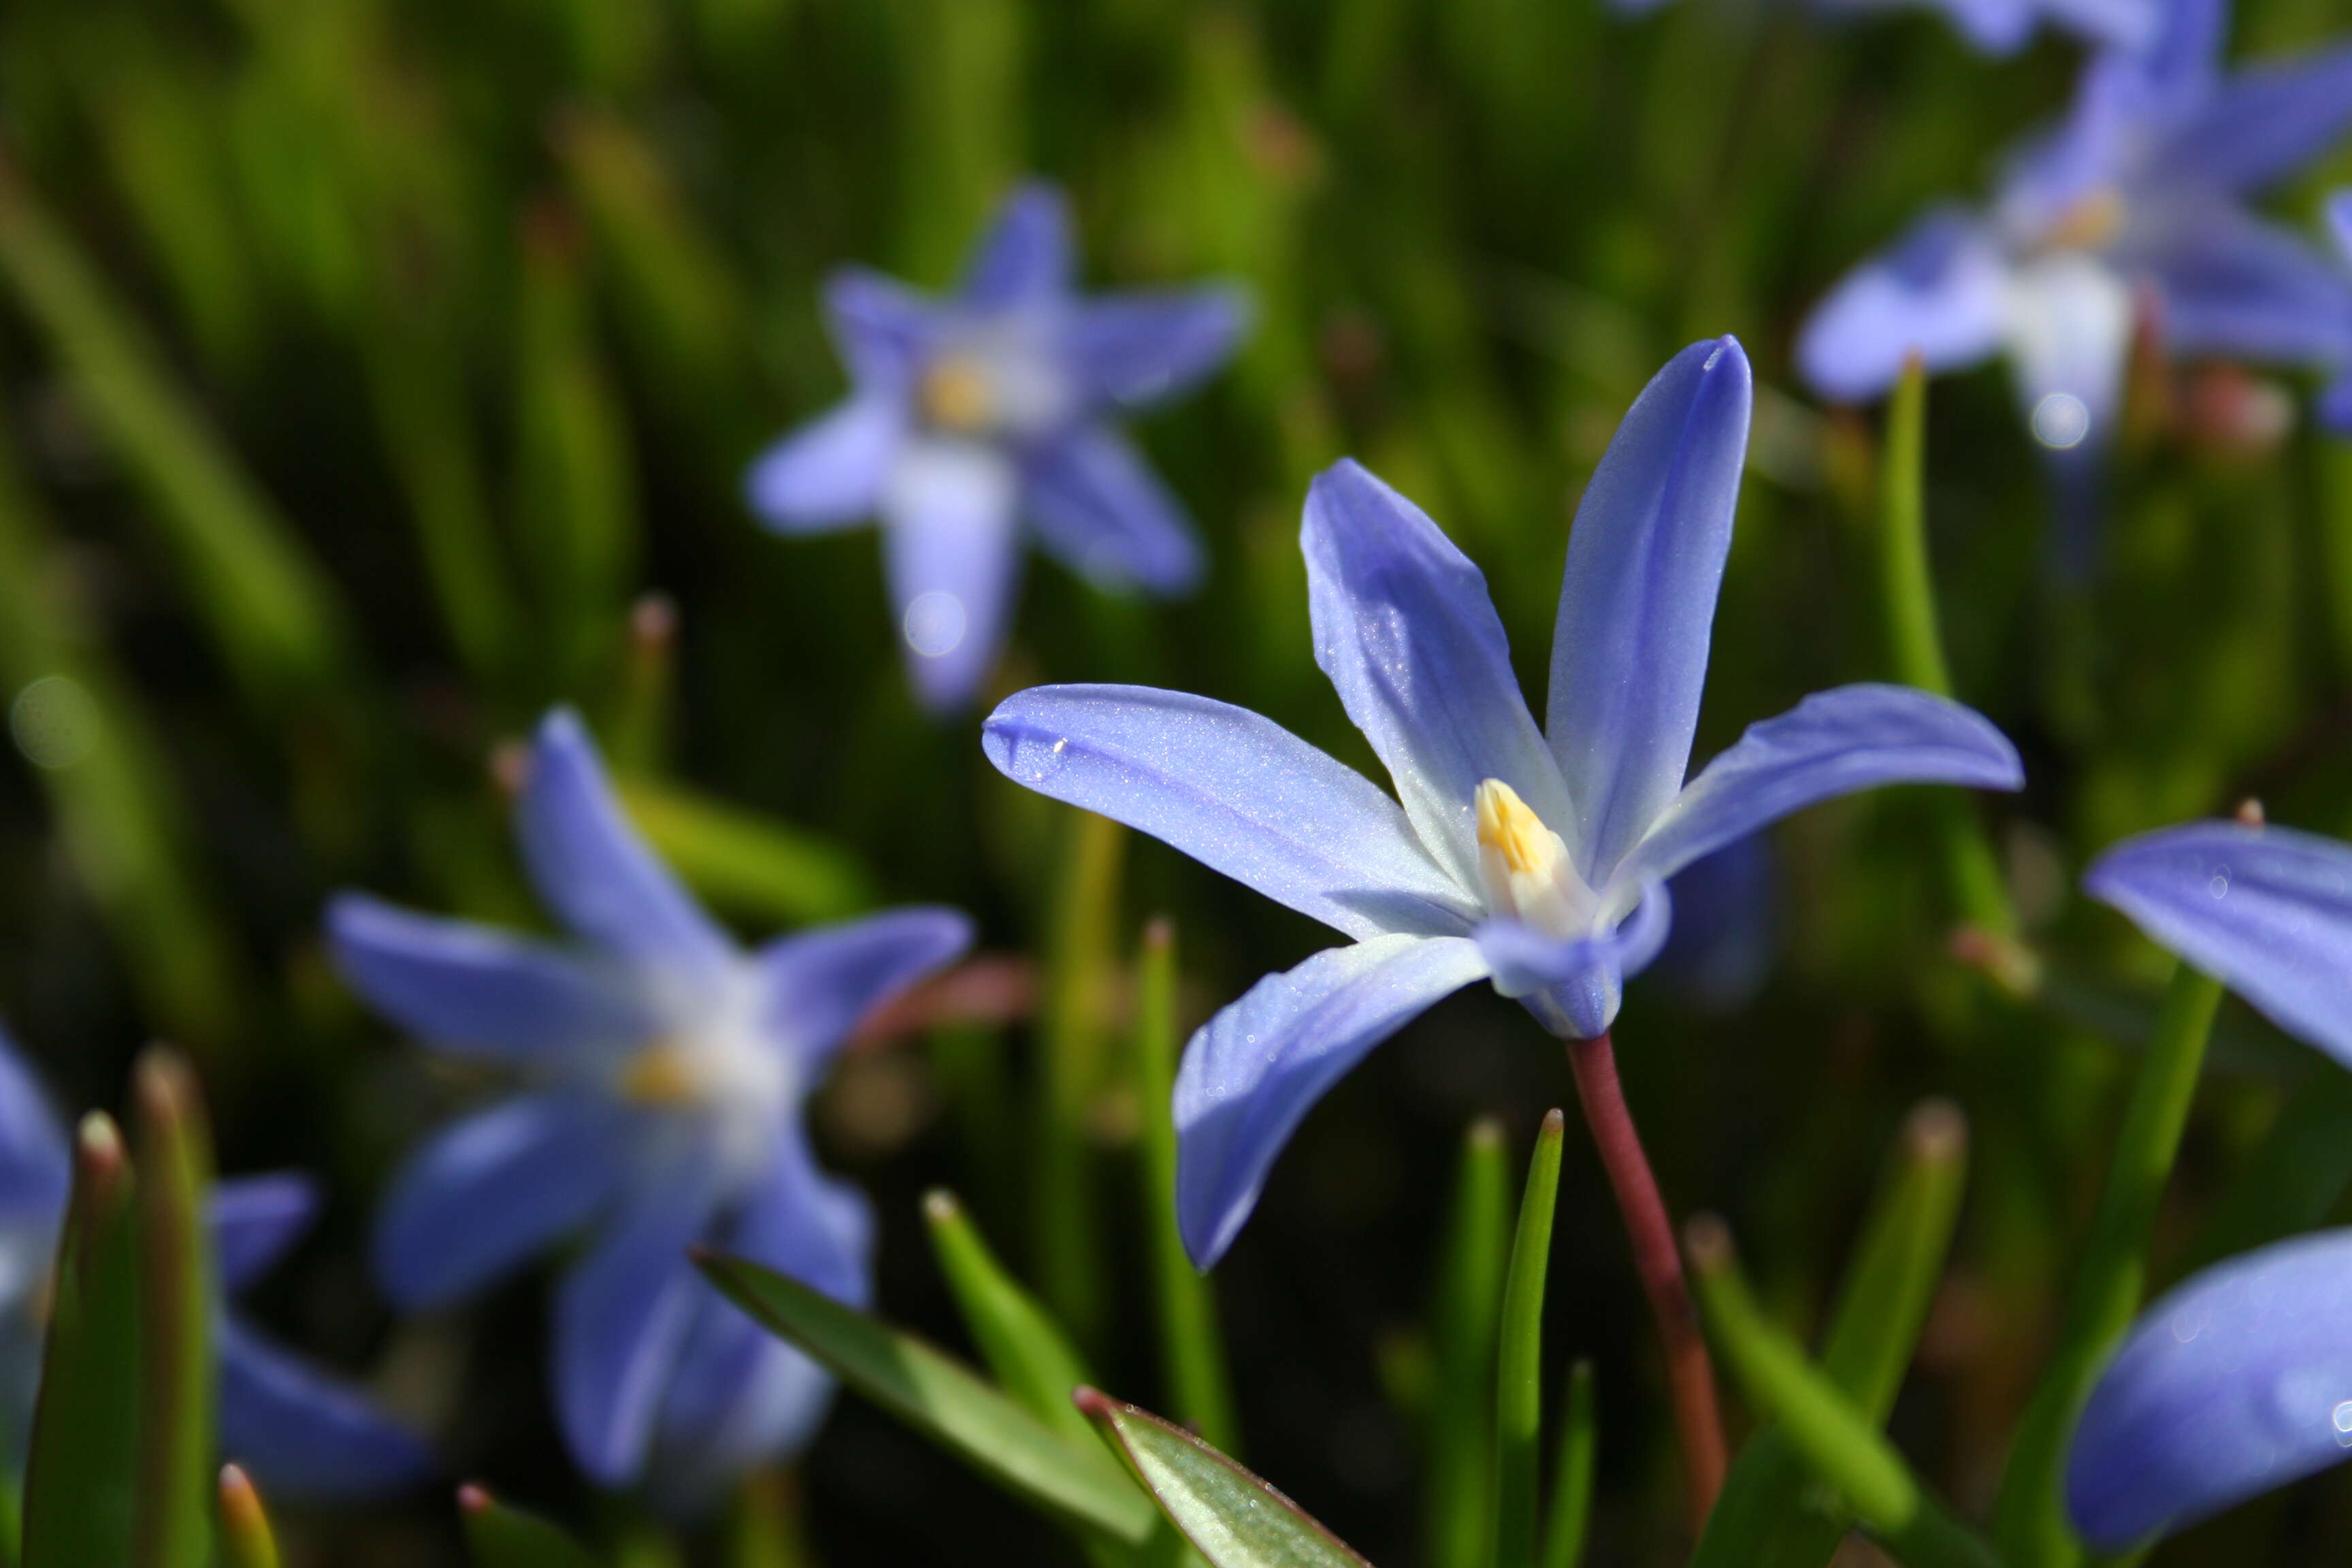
1797;0;2352;454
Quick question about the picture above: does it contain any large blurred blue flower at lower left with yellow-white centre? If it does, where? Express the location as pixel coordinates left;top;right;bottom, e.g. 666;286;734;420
327;713;971;1505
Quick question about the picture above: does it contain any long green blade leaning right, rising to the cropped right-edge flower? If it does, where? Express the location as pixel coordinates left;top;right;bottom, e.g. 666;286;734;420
1995;964;2220;1568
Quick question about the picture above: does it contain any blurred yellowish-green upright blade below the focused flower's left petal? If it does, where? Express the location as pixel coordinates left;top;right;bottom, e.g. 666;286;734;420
1030;811;1126;1345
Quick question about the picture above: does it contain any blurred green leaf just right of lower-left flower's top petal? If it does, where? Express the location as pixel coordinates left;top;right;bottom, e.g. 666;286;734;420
616;778;875;924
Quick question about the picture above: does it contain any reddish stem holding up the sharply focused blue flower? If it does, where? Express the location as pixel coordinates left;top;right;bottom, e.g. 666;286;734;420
1569;1034;1724;1526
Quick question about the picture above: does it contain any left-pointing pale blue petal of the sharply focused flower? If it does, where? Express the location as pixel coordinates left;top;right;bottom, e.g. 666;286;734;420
981;687;1480;936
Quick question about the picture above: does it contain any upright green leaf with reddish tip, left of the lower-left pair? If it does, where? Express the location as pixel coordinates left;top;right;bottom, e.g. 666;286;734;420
24;1112;139;1568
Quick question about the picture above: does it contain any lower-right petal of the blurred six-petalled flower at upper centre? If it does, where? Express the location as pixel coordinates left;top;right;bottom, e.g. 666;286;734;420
1023;425;1200;595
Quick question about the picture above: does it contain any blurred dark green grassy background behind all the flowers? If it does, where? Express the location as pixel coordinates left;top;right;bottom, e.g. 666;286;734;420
0;0;2352;1568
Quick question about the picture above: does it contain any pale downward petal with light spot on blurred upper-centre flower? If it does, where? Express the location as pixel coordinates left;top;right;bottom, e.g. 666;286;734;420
882;440;1021;713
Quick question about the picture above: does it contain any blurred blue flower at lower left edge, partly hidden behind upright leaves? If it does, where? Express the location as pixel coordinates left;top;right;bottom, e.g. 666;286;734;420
0;1036;433;1497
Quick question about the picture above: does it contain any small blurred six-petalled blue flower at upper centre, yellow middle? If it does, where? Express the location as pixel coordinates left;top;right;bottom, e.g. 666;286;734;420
746;183;1244;710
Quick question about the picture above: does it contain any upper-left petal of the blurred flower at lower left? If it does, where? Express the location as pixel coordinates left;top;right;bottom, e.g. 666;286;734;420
327;894;654;1062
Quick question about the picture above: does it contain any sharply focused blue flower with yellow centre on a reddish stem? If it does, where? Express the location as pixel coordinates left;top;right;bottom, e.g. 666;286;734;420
983;338;2021;1264
